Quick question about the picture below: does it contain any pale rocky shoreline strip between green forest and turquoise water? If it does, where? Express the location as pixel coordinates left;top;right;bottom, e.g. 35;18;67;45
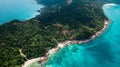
22;20;110;67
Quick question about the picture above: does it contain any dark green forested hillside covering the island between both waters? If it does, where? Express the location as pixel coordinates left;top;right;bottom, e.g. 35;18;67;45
0;0;118;67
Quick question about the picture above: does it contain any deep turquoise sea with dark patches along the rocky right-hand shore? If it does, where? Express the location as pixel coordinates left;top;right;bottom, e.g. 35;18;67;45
45;4;120;67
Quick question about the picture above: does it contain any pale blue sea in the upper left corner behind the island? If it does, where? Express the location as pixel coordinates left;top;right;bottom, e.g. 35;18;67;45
0;0;43;25
